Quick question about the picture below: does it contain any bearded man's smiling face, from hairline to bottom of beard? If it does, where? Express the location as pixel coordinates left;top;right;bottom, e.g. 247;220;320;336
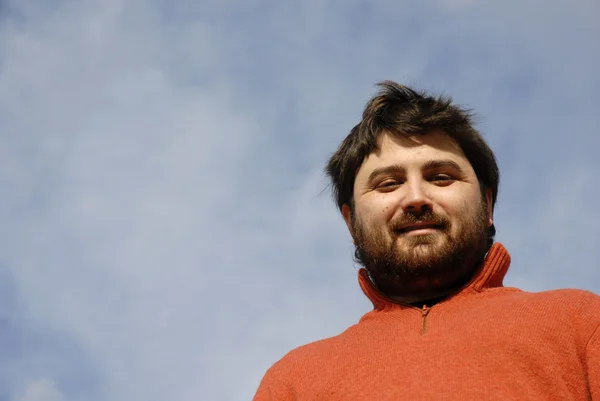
342;131;492;299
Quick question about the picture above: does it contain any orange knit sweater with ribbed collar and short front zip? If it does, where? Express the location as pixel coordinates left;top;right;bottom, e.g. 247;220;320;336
254;244;600;401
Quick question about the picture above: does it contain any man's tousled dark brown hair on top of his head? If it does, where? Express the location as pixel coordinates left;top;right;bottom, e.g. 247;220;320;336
325;81;500;239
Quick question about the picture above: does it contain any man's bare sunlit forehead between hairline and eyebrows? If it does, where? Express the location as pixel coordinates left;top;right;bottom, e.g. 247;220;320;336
357;131;474;178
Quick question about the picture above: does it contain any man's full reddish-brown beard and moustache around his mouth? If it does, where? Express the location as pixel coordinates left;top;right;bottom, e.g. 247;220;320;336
352;199;489;299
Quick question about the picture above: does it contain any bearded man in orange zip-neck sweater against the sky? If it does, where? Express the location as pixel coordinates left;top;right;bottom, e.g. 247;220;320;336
254;81;600;401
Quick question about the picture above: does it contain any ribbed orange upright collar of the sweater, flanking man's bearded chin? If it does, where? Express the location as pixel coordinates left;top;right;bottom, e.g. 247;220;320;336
358;242;510;309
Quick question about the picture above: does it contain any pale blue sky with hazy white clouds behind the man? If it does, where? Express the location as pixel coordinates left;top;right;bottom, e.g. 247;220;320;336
0;0;600;401
